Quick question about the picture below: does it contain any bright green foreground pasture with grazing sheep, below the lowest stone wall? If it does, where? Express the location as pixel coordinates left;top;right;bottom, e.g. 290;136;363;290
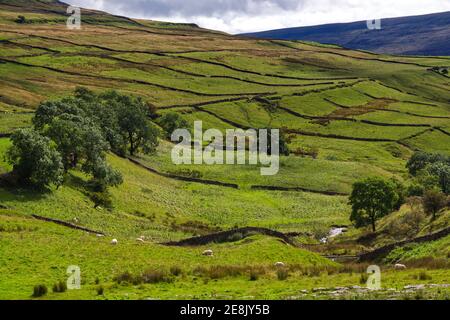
0;213;333;299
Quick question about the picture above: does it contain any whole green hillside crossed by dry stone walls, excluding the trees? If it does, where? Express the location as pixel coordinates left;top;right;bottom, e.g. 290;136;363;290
0;0;450;299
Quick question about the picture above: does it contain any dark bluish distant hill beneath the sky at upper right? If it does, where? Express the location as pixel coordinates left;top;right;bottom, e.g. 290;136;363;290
245;12;450;56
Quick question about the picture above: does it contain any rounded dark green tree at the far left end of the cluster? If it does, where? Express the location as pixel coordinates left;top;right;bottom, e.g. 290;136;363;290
6;129;64;188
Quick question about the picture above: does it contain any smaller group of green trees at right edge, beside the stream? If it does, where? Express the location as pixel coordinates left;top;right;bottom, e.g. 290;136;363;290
350;152;450;232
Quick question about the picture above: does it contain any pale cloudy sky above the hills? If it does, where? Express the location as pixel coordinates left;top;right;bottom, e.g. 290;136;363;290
65;0;450;33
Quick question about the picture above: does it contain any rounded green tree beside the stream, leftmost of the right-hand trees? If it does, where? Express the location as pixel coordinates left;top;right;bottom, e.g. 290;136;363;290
350;178;399;232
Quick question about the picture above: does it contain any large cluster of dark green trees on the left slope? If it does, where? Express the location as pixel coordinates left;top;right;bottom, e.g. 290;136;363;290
7;88;159;206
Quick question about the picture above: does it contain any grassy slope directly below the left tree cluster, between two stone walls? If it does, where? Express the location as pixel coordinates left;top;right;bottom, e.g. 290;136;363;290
0;146;348;236
